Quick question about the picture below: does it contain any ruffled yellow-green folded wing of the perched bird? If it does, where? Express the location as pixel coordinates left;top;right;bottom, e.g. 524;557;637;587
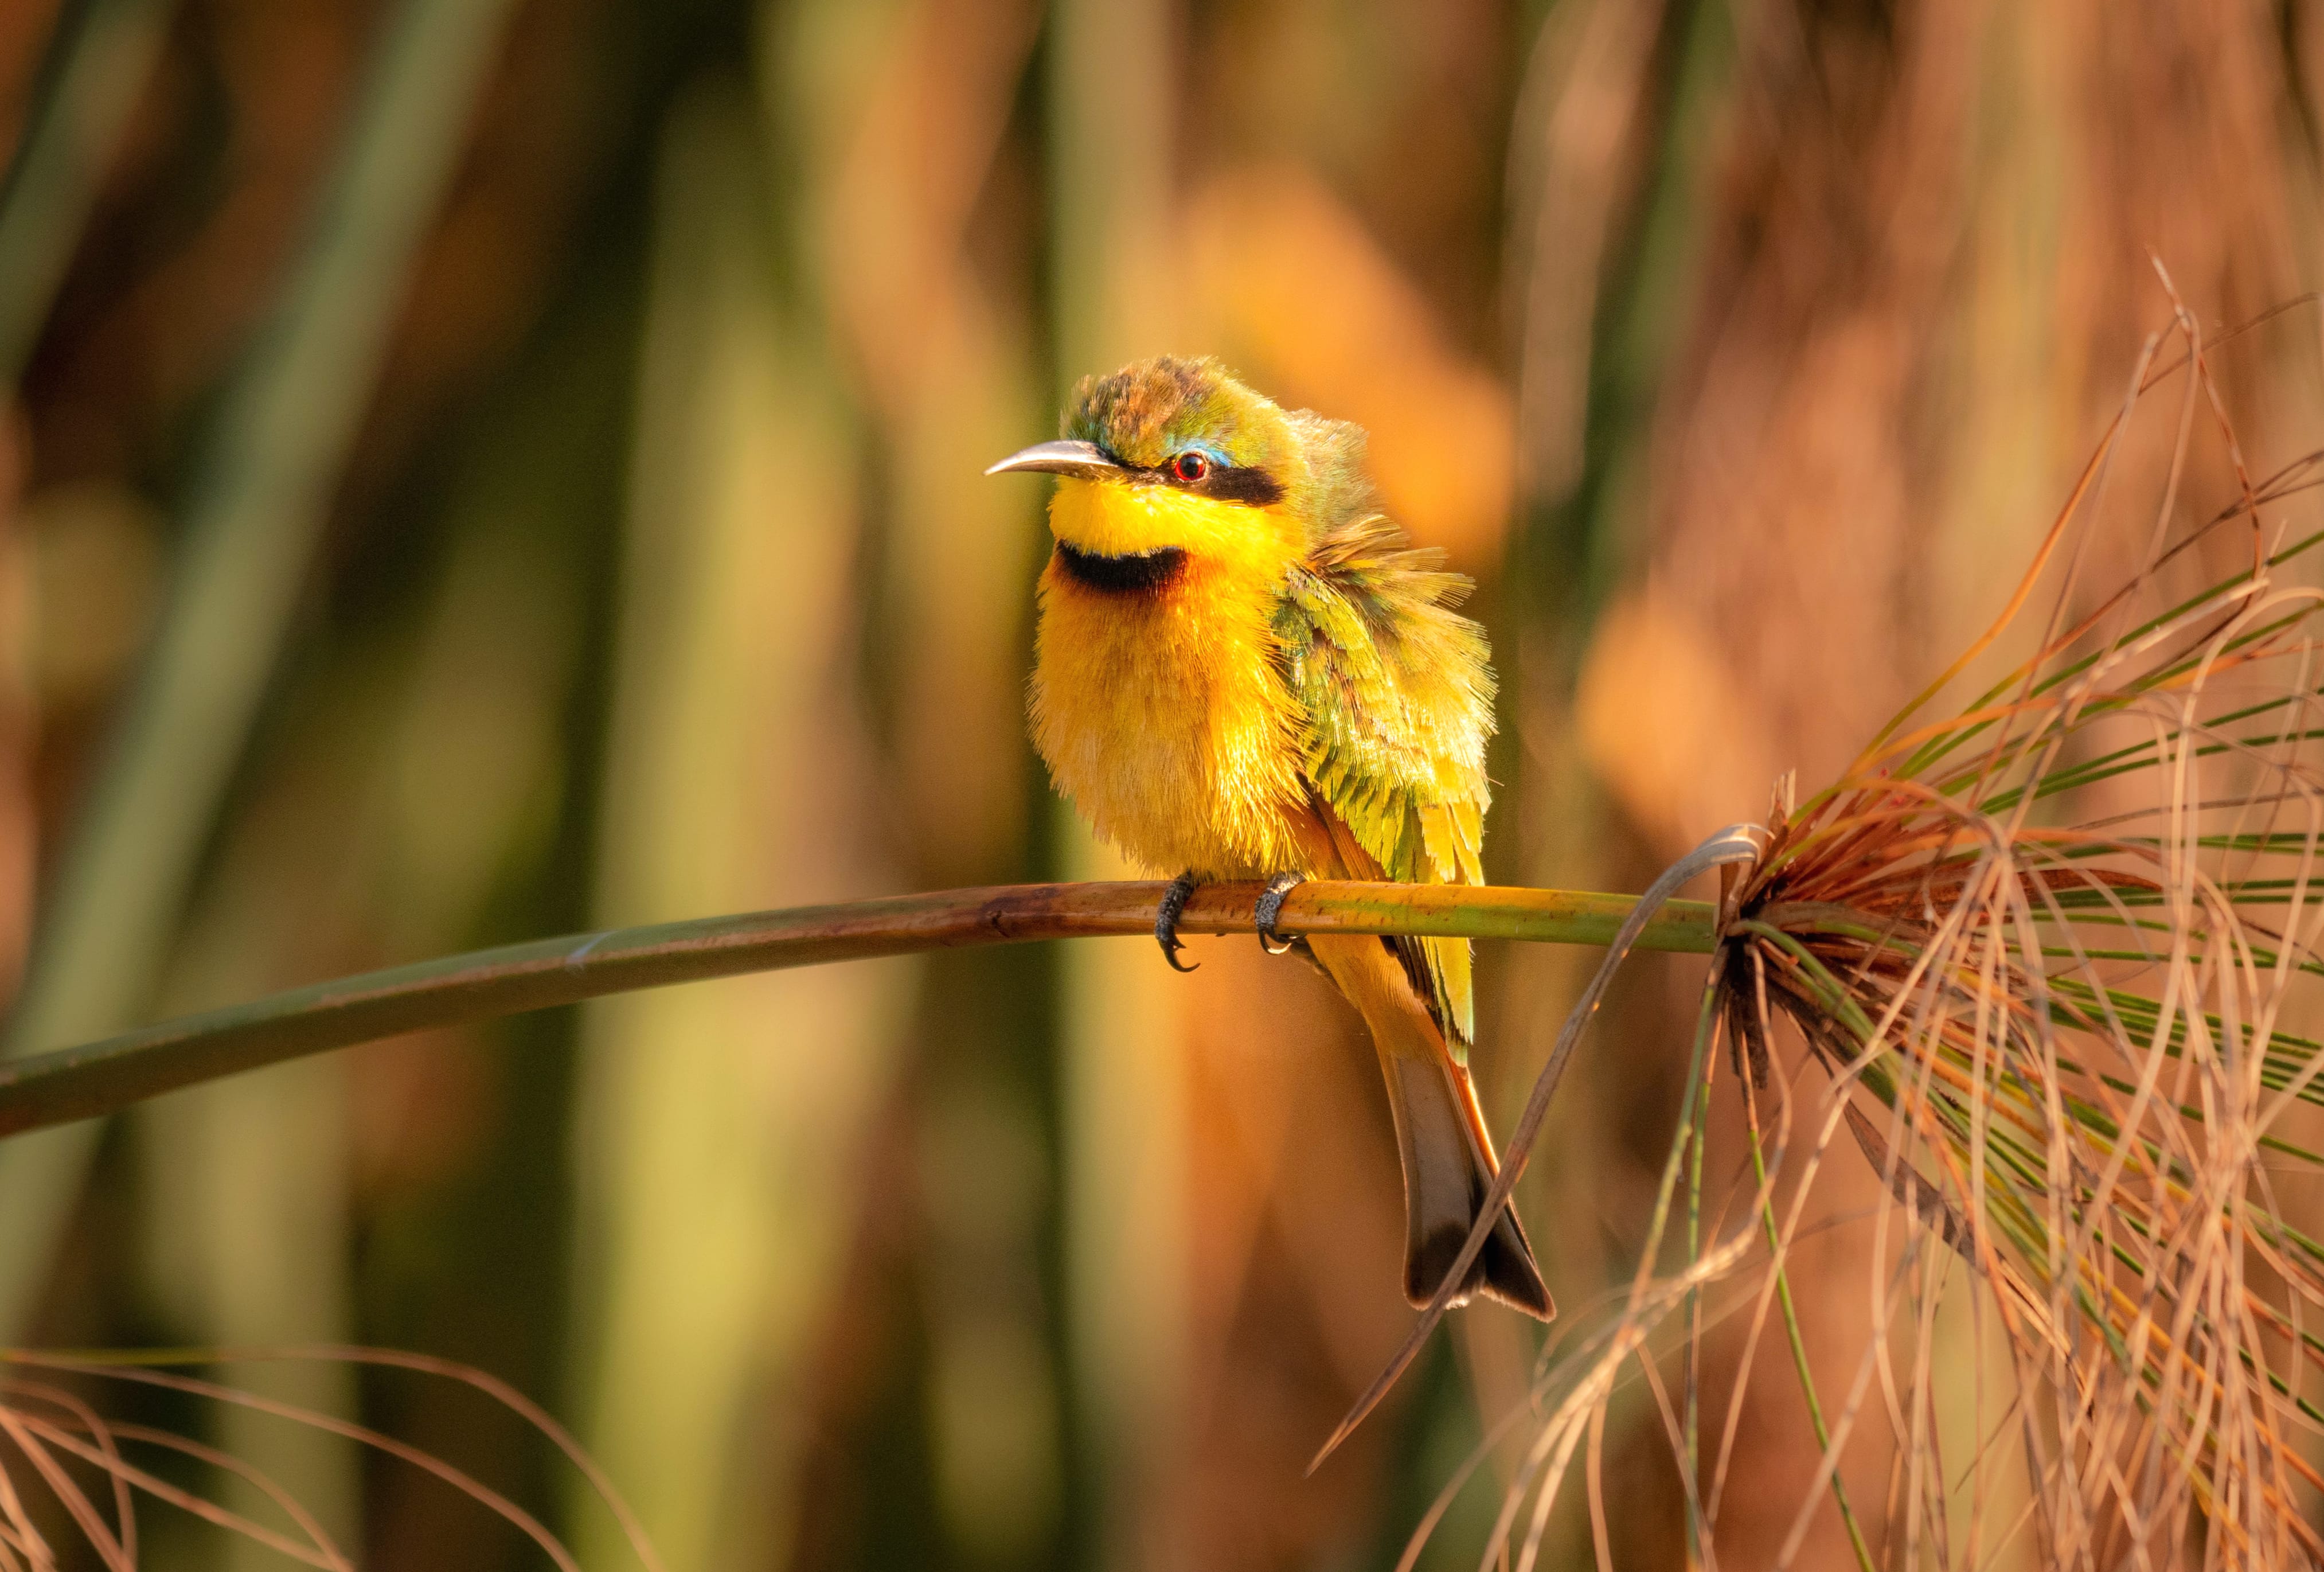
1276;514;1492;1063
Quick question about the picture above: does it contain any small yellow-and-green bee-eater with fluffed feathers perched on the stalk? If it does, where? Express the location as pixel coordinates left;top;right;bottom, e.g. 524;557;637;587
988;358;1554;1319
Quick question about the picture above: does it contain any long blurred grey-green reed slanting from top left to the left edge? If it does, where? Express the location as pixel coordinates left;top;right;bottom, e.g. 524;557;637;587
0;0;522;1330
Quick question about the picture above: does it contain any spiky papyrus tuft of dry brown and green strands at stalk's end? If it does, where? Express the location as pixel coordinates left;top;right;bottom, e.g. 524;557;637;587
1415;298;2324;1570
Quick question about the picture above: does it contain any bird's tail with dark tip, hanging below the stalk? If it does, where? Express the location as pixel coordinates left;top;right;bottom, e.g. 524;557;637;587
1309;935;1557;1321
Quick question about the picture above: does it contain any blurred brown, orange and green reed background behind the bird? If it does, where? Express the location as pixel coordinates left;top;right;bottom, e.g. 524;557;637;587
0;0;2324;1570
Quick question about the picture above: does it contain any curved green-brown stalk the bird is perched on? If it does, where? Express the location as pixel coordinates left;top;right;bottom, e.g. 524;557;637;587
0;881;1715;1137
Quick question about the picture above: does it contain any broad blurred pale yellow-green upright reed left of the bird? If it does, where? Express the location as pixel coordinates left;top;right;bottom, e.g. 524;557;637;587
574;81;913;1565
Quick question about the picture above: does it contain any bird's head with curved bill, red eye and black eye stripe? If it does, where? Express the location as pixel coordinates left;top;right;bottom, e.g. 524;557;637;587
985;356;1362;572
